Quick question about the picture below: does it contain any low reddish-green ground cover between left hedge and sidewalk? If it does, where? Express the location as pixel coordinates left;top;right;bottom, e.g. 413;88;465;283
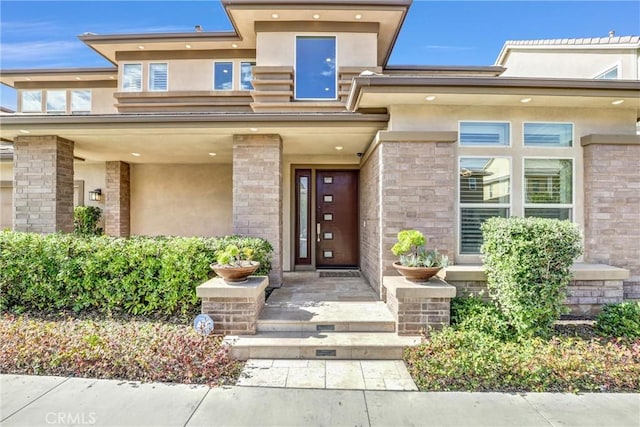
0;315;242;385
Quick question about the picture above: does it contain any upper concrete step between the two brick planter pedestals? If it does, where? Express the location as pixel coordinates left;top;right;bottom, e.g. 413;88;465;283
257;301;395;333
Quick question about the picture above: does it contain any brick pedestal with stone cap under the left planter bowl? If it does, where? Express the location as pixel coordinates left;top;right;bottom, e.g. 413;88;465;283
196;276;269;335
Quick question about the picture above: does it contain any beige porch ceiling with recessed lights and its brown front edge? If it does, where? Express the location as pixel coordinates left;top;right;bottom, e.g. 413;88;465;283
0;114;388;164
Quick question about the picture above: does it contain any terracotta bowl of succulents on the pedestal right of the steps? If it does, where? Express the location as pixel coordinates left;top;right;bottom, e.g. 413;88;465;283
391;230;449;283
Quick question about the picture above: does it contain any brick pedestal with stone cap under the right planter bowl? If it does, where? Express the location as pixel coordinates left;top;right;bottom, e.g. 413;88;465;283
382;276;456;335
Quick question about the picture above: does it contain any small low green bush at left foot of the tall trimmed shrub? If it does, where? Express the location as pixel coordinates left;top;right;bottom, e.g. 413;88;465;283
451;295;515;341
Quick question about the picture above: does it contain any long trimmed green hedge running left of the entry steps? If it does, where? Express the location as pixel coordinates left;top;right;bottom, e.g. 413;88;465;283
0;231;272;315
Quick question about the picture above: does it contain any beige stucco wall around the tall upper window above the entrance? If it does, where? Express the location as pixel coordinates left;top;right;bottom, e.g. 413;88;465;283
256;32;378;67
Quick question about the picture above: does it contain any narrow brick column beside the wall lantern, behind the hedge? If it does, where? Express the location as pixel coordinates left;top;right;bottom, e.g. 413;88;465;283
104;161;131;237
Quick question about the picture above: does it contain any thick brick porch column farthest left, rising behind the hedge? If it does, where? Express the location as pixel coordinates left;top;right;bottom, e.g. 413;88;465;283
13;135;74;233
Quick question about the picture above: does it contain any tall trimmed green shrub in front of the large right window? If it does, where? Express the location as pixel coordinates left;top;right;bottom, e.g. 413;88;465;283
482;217;582;336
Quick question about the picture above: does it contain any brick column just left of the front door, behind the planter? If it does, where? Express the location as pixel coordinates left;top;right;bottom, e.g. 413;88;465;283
233;135;282;286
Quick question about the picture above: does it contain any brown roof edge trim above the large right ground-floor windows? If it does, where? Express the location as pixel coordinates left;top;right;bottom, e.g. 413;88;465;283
346;76;640;111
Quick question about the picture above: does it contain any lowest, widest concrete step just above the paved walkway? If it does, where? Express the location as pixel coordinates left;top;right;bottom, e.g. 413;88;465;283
225;332;420;360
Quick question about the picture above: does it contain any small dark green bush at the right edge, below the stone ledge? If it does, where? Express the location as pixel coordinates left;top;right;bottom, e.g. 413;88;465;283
595;301;640;339
